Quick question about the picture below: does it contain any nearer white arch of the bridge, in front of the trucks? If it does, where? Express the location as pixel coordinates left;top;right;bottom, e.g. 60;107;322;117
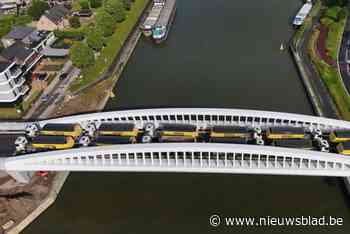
0;143;350;182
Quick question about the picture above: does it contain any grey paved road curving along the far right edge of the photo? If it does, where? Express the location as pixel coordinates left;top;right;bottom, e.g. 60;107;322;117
339;17;350;93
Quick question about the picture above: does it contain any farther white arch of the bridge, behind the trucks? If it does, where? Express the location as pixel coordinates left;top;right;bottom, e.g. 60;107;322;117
40;108;350;131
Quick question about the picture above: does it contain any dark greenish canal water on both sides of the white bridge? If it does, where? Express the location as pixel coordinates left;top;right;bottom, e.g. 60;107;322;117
24;0;350;234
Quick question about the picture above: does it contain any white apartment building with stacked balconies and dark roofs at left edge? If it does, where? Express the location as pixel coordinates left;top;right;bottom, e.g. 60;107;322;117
0;27;55;103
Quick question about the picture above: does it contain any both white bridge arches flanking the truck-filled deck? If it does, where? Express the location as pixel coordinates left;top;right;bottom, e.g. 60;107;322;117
0;108;350;182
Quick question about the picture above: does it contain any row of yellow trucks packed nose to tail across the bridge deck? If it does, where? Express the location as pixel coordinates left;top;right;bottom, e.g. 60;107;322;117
15;123;350;155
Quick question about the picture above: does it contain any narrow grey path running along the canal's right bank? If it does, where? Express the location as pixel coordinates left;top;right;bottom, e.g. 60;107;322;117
299;12;339;119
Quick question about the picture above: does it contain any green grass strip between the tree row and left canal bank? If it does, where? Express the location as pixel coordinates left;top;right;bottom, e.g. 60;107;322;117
69;0;149;92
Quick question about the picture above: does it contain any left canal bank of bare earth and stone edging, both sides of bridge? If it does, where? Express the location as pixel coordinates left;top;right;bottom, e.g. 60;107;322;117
6;0;149;234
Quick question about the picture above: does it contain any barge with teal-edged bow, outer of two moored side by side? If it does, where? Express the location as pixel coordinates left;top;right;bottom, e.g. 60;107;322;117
152;0;176;43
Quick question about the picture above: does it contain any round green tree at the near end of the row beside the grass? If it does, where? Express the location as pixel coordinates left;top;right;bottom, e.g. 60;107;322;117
69;41;95;68
